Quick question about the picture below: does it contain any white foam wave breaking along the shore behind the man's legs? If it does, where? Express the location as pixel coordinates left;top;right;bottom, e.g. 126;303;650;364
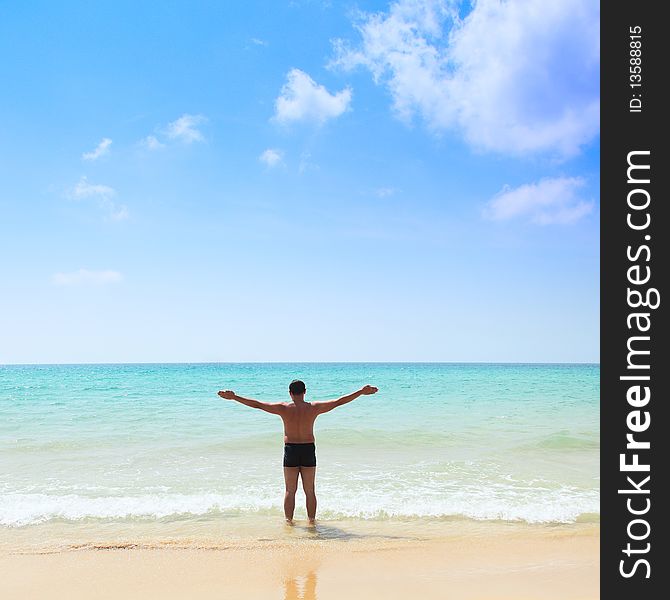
0;488;600;527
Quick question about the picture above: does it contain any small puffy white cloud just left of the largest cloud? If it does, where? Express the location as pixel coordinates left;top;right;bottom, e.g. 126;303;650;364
275;69;351;123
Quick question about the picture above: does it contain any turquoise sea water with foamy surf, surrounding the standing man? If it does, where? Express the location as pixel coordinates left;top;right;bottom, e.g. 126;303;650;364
0;363;600;528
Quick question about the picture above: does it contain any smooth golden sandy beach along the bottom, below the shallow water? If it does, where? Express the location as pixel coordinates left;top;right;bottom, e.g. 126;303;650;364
0;525;599;600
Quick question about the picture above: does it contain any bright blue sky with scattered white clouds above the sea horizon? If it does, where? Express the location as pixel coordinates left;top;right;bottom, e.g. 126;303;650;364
0;0;600;364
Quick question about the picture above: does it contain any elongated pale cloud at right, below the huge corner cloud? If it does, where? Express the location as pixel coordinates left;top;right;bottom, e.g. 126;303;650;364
484;177;593;225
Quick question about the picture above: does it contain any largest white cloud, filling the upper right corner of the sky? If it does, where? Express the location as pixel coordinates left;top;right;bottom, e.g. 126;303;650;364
332;0;600;157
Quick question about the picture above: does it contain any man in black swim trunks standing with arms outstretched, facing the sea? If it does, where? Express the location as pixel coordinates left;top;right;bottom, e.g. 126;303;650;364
219;379;377;525
